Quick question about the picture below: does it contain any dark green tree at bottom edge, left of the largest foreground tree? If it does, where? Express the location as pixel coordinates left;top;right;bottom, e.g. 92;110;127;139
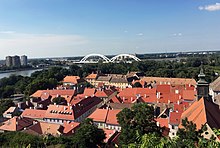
73;119;106;148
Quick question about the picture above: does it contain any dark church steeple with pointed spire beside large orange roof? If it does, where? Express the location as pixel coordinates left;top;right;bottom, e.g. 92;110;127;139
197;64;211;100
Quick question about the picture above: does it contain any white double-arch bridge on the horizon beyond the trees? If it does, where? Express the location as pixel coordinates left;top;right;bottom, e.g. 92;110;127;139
77;54;141;63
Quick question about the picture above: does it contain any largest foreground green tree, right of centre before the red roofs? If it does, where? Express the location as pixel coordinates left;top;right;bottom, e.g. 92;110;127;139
117;103;162;145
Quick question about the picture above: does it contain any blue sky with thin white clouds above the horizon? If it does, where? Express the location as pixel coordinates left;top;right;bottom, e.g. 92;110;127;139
0;0;220;59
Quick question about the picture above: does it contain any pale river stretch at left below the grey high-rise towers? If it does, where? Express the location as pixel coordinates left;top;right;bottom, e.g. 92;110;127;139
0;69;42;79
